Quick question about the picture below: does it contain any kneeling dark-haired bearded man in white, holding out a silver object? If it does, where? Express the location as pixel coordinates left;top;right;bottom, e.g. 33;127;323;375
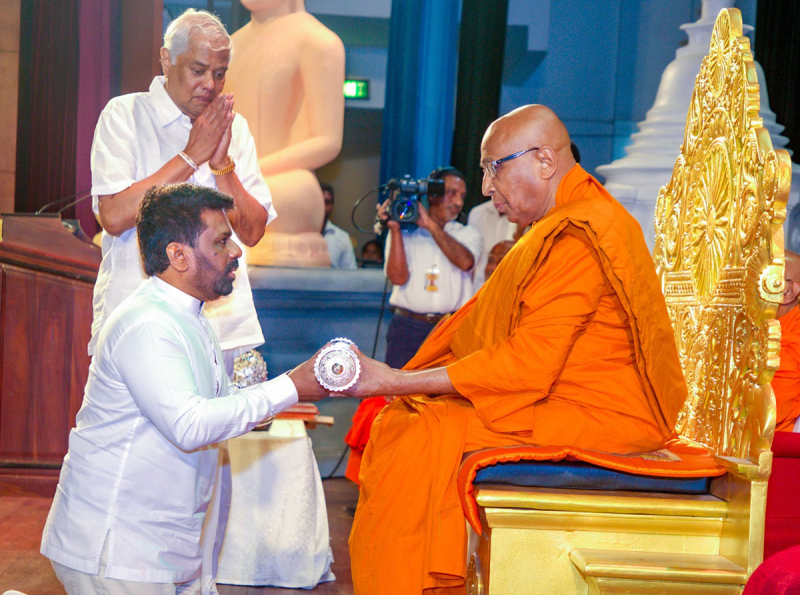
41;184;321;595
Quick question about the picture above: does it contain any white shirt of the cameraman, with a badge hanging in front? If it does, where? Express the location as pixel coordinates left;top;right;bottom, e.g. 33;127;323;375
384;221;483;314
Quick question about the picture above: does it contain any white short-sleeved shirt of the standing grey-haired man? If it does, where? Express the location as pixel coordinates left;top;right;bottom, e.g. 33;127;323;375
89;76;276;355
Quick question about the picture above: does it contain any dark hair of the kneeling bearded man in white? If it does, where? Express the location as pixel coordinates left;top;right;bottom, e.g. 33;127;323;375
136;183;234;276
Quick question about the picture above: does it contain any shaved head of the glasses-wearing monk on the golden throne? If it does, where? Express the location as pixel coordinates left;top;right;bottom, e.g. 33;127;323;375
481;105;575;227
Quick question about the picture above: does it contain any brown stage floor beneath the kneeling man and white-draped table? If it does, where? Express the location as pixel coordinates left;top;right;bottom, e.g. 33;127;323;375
0;478;358;595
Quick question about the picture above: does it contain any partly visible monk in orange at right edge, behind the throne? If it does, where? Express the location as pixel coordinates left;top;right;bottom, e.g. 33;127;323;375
772;250;800;432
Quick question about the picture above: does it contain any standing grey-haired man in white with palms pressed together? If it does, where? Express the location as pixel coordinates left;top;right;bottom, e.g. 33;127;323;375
89;9;276;364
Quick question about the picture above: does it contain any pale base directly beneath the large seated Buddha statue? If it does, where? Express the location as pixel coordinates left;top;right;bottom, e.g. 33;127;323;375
247;229;331;268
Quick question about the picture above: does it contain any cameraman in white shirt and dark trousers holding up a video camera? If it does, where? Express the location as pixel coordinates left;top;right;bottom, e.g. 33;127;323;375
378;167;483;368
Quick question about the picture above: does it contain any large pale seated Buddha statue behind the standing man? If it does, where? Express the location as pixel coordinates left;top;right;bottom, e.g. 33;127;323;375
225;0;344;267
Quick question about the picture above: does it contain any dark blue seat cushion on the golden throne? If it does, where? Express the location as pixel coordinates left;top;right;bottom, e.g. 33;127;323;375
473;461;711;494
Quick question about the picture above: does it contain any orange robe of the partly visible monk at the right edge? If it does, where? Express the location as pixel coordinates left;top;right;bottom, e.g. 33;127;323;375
772;307;800;432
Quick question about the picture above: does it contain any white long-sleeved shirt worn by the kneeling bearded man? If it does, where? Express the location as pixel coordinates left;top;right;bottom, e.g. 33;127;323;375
41;277;297;583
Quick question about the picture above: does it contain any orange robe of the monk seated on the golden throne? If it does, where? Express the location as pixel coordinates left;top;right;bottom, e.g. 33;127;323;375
350;166;686;595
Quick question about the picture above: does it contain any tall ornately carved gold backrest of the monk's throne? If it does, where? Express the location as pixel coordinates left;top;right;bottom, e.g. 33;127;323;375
653;8;791;460
